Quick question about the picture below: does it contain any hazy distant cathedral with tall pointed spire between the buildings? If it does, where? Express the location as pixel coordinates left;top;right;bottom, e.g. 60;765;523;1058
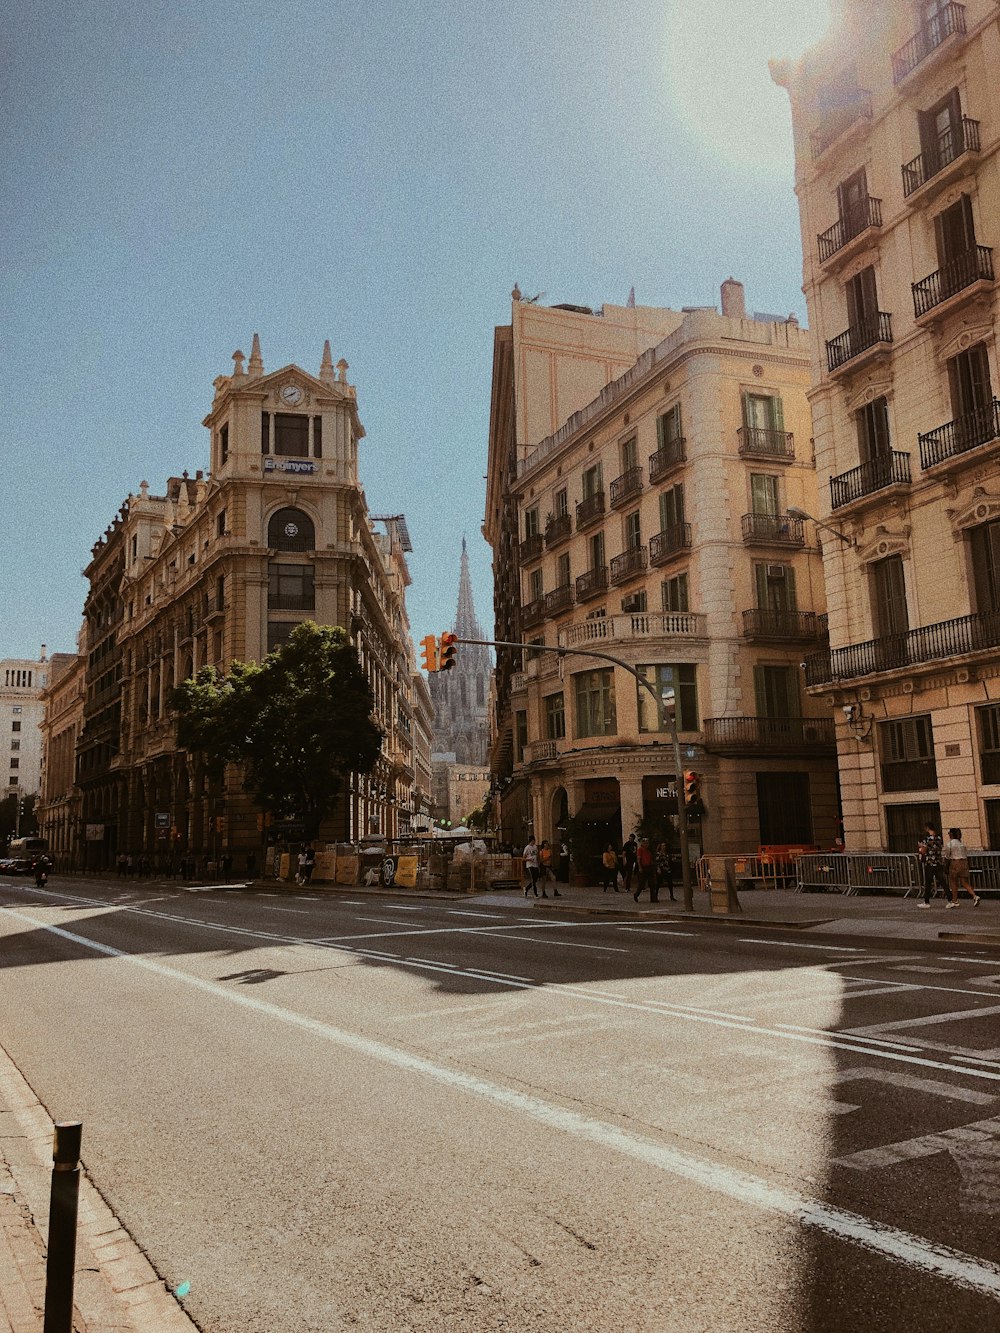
429;537;491;768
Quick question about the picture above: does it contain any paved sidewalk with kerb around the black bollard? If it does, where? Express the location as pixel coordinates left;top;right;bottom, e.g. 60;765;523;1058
0;1046;196;1333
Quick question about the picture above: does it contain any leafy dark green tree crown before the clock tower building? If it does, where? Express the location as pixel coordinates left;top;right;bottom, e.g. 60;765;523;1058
172;620;383;838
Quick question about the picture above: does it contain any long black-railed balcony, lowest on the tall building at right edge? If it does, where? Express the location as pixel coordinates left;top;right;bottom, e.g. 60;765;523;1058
805;612;1000;685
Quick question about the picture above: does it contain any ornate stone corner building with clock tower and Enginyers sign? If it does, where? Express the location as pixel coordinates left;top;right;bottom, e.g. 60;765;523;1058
58;335;429;868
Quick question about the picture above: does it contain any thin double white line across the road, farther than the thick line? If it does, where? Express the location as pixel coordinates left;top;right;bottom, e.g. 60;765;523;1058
4;889;1000;1082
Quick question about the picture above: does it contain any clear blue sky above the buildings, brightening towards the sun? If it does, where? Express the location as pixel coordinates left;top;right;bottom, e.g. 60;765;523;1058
0;0;827;657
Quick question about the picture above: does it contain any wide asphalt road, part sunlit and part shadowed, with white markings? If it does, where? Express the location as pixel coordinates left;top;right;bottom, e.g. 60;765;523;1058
0;880;1000;1333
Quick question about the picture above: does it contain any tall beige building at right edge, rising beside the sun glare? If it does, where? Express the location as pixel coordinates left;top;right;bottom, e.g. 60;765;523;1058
772;0;1000;850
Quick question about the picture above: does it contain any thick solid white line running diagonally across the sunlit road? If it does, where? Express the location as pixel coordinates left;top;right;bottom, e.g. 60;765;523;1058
8;909;1000;1300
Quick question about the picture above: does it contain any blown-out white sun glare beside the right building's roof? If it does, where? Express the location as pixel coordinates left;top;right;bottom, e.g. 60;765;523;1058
667;0;829;173
